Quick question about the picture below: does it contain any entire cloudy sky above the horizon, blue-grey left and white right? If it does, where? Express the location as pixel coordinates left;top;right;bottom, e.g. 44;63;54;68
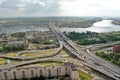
0;0;120;17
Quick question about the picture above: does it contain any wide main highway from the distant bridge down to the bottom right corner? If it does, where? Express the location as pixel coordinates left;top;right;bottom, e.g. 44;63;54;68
50;21;120;80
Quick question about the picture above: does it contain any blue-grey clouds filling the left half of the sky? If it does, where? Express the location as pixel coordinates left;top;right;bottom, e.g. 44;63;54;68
0;0;60;17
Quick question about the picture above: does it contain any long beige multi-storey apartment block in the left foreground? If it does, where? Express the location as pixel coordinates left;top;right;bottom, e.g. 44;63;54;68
0;63;79;80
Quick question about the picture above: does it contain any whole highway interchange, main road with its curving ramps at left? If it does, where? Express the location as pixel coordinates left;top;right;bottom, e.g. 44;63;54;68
0;21;120;80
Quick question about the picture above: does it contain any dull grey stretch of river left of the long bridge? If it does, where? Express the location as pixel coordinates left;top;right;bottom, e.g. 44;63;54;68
0;24;49;34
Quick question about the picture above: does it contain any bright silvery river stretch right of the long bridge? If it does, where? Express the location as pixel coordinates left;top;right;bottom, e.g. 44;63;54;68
60;20;120;33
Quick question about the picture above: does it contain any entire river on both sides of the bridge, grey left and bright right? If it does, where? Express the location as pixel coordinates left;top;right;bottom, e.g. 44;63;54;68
0;20;120;33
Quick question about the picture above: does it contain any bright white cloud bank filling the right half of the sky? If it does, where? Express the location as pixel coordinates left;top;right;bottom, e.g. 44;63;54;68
60;0;120;16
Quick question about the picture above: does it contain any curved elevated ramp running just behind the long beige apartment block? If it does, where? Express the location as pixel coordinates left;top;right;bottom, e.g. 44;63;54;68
0;57;83;70
